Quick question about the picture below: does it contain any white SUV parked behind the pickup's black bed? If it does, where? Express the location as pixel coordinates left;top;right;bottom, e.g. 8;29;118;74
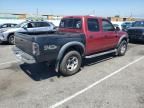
0;21;56;44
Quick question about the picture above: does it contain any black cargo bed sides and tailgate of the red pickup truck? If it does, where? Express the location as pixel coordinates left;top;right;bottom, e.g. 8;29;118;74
15;33;85;61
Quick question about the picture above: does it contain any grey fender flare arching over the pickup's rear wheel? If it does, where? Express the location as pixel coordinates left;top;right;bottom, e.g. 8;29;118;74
55;41;85;72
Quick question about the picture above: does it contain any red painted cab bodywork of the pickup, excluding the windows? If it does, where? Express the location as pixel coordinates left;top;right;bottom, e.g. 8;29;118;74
59;16;126;55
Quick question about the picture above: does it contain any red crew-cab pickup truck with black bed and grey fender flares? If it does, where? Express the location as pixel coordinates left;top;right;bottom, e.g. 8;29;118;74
14;16;128;76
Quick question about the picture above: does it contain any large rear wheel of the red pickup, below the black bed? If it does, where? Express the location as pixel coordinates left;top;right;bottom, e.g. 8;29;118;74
59;51;82;76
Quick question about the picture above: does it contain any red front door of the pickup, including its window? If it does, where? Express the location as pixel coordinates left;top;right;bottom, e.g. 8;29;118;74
102;19;118;50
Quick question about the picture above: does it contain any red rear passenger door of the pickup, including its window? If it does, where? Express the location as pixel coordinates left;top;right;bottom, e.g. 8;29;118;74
86;18;104;54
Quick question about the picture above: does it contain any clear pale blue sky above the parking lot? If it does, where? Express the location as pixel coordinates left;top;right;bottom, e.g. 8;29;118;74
0;0;144;17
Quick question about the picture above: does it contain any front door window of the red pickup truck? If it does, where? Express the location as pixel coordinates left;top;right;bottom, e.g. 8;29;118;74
102;20;115;31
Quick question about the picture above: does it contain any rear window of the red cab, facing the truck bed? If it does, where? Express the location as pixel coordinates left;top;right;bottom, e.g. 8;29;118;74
60;18;82;29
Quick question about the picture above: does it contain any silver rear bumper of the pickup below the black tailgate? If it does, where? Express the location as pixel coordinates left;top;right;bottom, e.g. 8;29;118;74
13;47;36;64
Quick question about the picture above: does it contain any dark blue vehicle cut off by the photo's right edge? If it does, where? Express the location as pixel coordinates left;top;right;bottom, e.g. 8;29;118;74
127;21;144;42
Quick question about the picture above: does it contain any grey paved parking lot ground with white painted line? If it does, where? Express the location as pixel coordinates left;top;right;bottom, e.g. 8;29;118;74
0;44;144;108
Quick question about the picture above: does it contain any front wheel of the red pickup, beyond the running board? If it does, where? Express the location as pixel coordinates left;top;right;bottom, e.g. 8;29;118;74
117;40;128;56
